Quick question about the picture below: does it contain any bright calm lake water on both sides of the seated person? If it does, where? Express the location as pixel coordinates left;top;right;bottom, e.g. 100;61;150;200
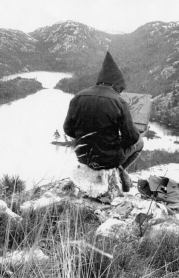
0;72;179;187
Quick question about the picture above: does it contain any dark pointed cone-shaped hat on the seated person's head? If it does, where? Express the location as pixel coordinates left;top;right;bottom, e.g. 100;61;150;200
96;51;126;93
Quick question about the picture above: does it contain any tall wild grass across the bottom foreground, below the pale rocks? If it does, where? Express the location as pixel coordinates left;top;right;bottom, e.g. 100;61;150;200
1;192;179;278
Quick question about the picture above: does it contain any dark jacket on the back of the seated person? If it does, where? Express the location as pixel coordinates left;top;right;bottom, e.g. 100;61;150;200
64;85;138;169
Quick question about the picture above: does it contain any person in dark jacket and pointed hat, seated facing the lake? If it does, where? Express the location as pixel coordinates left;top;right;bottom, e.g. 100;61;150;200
63;52;143;192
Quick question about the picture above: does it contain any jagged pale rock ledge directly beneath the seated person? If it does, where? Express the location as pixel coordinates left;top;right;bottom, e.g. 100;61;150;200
21;169;178;240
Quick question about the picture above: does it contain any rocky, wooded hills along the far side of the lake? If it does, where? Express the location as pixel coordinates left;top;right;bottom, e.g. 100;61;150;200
0;21;179;126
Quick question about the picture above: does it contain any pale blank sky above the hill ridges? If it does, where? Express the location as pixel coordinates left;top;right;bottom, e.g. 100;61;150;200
0;0;179;33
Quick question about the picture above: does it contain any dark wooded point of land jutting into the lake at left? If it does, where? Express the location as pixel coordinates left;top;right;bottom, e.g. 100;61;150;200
0;77;43;104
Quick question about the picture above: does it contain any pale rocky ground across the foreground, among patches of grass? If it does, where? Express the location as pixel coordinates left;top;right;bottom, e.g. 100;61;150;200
0;164;179;277
